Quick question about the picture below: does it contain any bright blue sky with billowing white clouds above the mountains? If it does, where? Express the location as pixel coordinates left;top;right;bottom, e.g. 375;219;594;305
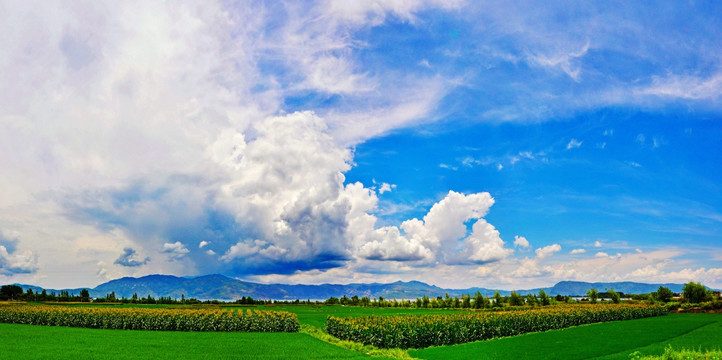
0;0;722;289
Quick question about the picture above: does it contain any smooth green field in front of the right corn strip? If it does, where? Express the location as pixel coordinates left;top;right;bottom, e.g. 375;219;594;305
409;314;722;360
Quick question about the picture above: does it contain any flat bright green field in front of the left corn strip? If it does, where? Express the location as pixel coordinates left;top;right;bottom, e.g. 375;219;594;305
0;324;371;360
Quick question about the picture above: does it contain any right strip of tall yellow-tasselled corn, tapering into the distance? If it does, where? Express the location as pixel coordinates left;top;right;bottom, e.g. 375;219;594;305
326;305;667;349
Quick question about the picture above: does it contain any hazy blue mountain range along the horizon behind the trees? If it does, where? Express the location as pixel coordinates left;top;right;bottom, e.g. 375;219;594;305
7;274;683;300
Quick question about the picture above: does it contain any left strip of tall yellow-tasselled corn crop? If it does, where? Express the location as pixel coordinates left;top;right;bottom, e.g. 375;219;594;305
0;305;300;332
